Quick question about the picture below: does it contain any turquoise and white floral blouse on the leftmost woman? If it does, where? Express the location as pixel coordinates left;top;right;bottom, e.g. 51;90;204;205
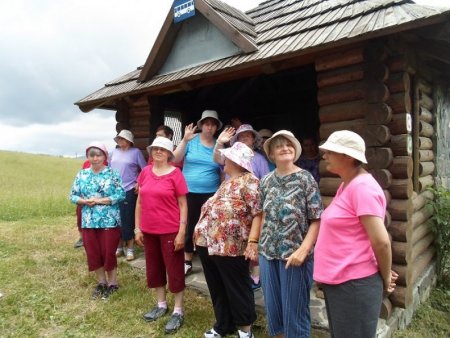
70;167;125;229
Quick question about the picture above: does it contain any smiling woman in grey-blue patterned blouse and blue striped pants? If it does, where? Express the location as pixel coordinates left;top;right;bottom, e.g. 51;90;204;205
252;130;323;338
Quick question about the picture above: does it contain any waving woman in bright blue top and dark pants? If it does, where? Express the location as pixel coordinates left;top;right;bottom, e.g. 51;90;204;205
174;110;222;275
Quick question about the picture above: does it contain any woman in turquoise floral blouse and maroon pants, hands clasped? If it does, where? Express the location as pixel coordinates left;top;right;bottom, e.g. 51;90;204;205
70;142;125;299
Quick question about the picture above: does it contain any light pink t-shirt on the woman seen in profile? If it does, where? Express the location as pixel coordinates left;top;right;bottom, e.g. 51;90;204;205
314;174;386;284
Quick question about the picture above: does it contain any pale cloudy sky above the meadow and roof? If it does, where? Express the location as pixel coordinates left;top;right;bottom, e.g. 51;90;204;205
0;0;450;156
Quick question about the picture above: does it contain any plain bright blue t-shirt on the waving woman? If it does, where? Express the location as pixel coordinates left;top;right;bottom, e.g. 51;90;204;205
183;135;220;194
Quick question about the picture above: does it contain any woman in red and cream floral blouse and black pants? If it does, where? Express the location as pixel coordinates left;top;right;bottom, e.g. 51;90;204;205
194;142;261;338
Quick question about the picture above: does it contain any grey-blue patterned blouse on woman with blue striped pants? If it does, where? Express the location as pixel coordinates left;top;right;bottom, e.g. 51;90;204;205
258;169;323;259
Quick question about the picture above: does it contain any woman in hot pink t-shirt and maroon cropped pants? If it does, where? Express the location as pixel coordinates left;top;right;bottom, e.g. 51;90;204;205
135;136;188;333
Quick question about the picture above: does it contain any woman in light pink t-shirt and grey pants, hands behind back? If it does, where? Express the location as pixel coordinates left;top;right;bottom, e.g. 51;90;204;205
314;130;398;338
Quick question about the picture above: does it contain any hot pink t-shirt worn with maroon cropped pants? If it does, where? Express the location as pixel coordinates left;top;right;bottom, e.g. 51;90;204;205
137;166;188;235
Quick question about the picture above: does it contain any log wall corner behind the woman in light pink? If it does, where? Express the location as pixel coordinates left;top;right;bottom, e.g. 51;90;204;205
316;43;435;318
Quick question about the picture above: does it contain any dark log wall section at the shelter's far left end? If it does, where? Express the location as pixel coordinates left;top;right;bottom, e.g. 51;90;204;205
116;96;150;157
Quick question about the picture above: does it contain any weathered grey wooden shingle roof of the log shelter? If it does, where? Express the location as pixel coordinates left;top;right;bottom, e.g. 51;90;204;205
76;0;450;110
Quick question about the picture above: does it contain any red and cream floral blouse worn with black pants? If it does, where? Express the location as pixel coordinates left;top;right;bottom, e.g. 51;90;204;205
194;173;261;257
